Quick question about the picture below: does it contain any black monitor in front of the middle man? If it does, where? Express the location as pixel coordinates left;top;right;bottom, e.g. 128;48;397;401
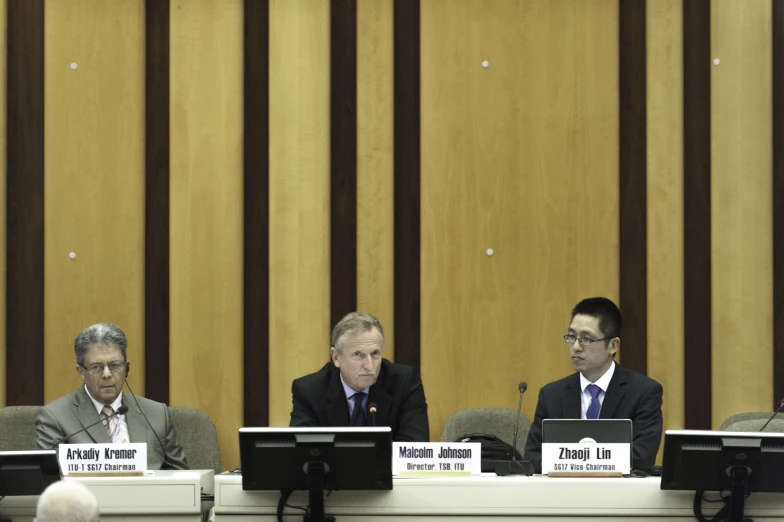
240;426;392;521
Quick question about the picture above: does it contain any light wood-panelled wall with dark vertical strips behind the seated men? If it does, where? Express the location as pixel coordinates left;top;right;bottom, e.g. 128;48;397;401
0;0;784;469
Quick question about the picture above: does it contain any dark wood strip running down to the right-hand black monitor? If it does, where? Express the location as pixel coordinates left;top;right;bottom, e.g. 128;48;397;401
683;0;711;429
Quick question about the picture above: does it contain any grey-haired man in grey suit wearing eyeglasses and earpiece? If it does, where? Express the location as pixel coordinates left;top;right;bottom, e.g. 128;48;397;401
35;324;188;469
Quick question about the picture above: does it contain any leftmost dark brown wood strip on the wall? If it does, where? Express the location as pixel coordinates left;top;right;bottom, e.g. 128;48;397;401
6;0;44;406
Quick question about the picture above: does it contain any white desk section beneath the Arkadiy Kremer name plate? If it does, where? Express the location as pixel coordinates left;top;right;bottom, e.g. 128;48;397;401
0;470;215;522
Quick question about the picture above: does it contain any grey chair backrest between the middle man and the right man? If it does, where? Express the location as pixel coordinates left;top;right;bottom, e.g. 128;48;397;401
441;408;531;457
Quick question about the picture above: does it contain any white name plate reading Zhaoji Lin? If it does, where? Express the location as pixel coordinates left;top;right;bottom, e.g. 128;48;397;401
542;442;631;475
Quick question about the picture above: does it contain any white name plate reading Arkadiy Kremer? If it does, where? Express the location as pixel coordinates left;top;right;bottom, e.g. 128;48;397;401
57;442;147;475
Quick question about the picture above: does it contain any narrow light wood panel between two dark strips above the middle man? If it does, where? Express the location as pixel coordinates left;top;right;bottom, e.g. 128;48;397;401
357;0;395;359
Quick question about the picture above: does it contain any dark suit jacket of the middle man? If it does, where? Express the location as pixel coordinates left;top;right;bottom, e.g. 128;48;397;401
290;359;430;442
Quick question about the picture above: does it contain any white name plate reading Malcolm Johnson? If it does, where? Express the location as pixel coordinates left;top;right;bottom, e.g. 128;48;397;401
392;442;482;476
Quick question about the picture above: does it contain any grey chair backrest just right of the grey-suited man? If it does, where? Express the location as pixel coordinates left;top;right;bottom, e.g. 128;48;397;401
169;406;221;475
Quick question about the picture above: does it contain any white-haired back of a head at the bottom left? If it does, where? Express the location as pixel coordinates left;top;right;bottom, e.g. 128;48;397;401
35;480;100;522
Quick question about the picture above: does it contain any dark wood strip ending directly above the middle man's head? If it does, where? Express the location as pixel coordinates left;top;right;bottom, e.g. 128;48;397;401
330;0;357;325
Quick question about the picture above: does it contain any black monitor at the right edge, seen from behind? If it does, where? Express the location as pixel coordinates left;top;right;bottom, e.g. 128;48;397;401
661;430;784;521
